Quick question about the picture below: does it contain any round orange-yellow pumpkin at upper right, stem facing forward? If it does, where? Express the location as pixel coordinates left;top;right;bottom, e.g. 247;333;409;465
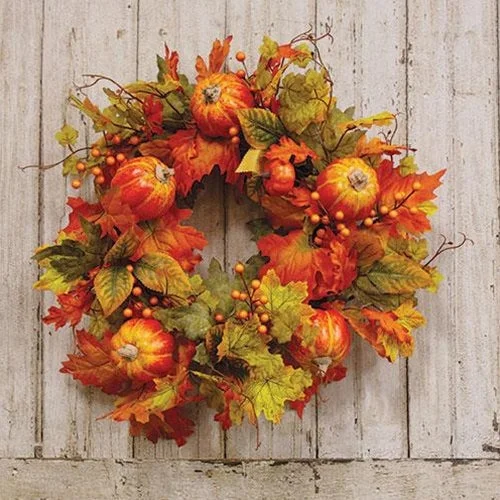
316;158;379;220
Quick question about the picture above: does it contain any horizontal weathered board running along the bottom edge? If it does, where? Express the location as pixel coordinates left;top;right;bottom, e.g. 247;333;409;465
0;459;500;500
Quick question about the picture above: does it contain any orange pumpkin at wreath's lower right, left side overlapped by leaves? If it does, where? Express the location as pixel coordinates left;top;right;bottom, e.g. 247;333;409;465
310;309;351;365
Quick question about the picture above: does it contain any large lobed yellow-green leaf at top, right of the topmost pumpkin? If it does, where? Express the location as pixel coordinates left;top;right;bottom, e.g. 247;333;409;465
279;69;330;134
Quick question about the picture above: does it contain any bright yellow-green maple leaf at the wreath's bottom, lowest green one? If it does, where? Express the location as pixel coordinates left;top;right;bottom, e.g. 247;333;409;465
242;365;313;424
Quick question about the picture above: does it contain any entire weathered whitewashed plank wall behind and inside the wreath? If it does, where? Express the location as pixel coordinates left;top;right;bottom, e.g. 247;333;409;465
0;0;500;498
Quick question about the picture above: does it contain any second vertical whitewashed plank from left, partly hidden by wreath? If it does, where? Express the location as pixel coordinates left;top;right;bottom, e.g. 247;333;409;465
40;0;137;458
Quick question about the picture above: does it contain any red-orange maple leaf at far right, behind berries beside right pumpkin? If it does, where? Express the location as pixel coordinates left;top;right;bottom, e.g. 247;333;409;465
377;160;445;234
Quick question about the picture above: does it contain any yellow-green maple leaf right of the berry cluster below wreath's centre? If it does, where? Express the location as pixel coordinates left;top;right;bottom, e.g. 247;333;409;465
256;269;314;343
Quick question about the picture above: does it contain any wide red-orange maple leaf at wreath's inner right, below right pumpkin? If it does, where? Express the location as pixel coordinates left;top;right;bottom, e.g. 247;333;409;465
257;230;356;299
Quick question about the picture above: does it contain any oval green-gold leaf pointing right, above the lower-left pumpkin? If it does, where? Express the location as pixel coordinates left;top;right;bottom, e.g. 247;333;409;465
134;252;192;298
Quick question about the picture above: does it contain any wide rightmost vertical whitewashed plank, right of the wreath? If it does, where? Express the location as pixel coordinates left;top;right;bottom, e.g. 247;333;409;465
408;1;500;457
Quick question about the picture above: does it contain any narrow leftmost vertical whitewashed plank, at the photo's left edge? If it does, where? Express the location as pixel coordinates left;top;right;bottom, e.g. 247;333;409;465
0;1;42;456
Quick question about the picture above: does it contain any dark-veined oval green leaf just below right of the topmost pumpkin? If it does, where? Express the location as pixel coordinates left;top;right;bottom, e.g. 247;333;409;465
237;108;286;150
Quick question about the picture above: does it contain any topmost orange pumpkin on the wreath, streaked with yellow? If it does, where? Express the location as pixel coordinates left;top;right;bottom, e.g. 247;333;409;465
191;73;254;137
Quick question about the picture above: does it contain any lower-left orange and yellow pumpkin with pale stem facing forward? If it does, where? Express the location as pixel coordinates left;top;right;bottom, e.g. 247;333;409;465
111;319;175;382
